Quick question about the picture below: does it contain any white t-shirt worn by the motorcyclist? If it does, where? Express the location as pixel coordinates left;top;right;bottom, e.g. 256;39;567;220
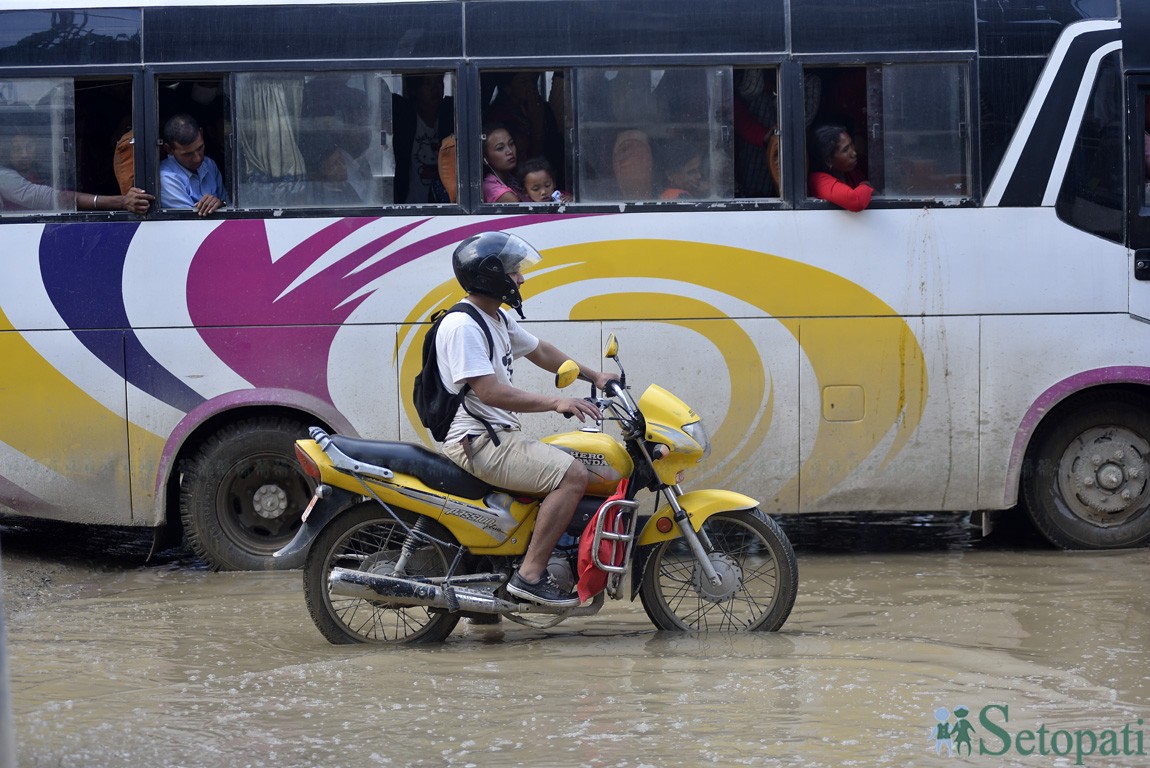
435;299;539;443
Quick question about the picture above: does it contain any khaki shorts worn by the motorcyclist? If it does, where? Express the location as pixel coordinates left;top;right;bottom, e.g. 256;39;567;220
443;430;575;496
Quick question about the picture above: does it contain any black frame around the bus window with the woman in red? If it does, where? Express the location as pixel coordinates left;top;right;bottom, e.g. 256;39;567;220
800;51;983;210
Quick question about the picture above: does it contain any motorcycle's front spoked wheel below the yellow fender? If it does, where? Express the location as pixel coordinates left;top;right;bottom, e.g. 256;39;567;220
639;509;798;632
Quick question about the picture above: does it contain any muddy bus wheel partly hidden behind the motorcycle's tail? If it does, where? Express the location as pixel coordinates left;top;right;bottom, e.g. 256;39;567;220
179;416;314;570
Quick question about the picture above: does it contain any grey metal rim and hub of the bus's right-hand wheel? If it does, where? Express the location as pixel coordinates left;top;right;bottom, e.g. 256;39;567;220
1059;427;1150;527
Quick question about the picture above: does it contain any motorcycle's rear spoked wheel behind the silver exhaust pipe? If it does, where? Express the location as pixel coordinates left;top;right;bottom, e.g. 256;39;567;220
304;501;459;645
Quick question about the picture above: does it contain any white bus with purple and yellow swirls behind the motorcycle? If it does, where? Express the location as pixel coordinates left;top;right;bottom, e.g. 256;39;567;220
0;0;1150;569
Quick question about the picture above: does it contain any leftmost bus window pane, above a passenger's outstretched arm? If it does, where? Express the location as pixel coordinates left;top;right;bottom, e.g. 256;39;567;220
0;78;76;214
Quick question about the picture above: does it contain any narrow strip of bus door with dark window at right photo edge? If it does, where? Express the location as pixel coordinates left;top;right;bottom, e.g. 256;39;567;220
1126;72;1150;320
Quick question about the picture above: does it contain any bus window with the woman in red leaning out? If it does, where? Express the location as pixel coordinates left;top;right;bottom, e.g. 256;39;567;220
807;63;971;200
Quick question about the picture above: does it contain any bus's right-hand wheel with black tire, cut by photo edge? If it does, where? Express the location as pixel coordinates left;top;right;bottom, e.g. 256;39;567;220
1022;392;1150;550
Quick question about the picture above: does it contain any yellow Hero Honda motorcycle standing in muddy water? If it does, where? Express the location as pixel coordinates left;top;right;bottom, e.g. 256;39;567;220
276;336;798;645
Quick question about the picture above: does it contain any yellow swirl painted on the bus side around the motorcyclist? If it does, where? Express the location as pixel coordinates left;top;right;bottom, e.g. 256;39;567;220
400;239;927;506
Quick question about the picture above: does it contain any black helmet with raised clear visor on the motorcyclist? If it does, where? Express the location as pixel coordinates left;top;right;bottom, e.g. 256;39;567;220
451;232;543;317
